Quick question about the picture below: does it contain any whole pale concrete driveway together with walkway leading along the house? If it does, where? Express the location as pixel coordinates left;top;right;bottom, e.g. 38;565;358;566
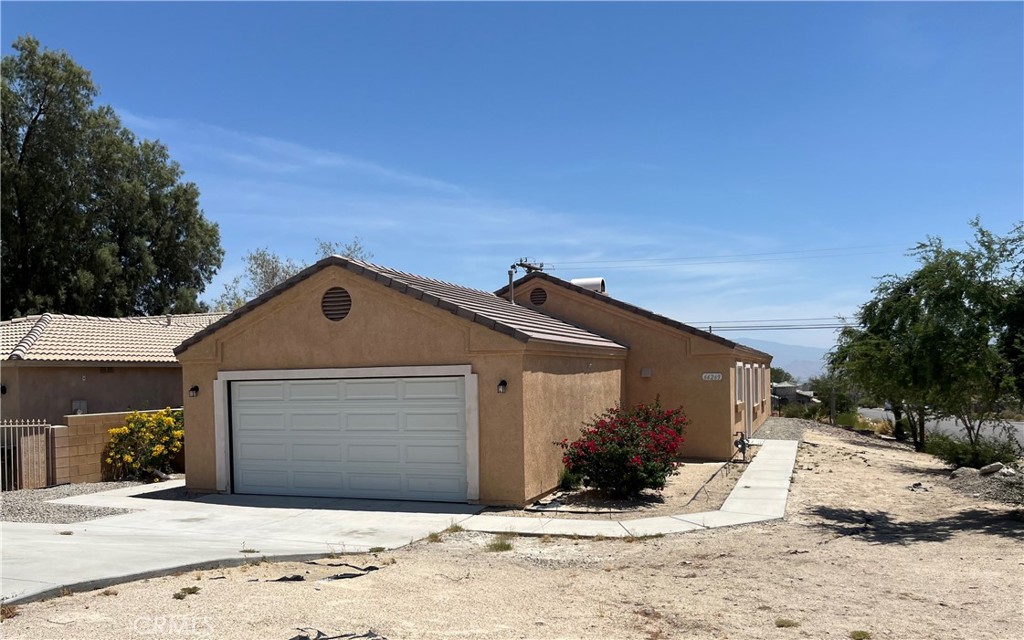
0;440;798;602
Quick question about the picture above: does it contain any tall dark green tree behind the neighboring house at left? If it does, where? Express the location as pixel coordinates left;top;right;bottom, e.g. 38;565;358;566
0;36;223;318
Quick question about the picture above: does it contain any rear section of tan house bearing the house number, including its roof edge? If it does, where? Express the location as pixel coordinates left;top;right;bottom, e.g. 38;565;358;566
496;271;772;460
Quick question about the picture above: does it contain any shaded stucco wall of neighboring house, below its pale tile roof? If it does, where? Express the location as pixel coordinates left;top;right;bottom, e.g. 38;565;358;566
0;361;181;424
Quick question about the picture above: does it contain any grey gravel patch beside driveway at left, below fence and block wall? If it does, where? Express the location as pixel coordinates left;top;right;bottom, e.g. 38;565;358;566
0;481;142;524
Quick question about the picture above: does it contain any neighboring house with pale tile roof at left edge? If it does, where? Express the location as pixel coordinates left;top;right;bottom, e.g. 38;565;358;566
0;313;224;424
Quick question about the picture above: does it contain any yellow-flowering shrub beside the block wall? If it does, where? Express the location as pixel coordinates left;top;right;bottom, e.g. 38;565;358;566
106;409;185;479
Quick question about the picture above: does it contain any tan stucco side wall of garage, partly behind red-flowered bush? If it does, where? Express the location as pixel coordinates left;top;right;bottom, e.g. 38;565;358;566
522;353;624;500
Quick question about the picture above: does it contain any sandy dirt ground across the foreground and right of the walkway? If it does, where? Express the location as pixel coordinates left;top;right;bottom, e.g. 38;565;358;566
0;421;1024;640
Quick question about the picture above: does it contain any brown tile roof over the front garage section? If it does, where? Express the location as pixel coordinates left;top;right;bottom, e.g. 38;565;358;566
174;256;626;353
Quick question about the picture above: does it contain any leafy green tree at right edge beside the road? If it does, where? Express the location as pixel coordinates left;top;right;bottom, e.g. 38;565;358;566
830;219;1024;451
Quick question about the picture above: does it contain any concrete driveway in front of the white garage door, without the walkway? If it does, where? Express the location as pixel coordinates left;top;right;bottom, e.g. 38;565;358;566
0;480;482;601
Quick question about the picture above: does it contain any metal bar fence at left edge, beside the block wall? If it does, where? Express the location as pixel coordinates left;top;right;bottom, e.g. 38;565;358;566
0;420;55;492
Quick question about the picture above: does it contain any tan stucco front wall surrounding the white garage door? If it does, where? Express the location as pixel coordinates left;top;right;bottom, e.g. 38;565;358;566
178;266;622;504
